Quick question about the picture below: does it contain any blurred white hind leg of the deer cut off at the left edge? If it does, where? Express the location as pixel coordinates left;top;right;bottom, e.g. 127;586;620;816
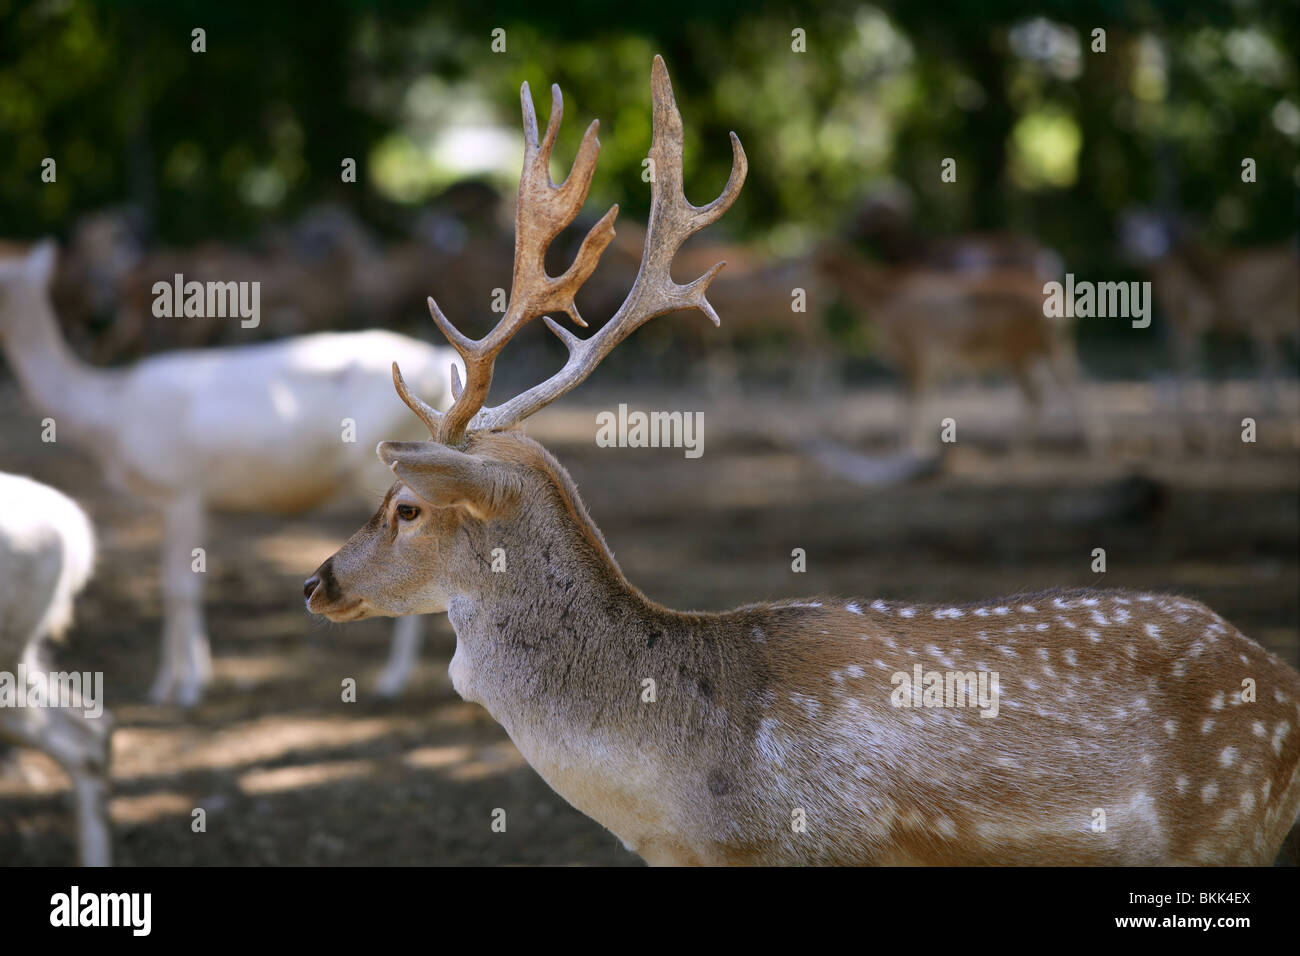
0;708;112;866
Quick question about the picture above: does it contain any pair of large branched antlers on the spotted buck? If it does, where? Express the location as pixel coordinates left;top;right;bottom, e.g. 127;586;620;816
393;56;749;445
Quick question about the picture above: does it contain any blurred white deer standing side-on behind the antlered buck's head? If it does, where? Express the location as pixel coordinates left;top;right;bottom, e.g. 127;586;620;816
0;241;459;708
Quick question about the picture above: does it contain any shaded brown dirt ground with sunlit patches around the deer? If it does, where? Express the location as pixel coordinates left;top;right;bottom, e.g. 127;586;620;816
0;381;1300;865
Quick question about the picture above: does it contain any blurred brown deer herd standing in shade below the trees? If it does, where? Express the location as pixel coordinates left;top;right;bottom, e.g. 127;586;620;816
32;182;1300;454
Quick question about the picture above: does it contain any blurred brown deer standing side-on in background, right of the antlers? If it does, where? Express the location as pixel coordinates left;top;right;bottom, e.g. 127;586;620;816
815;243;1105;455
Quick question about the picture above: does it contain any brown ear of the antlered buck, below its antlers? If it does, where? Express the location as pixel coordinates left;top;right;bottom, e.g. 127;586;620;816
374;441;521;520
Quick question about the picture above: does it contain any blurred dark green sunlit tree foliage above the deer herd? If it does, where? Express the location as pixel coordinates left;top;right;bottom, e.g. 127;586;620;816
0;0;1300;268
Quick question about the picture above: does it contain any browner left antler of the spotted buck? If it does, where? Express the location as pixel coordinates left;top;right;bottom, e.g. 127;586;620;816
428;77;619;445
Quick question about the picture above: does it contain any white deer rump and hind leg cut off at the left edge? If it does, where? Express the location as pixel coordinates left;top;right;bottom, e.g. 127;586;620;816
0;472;113;866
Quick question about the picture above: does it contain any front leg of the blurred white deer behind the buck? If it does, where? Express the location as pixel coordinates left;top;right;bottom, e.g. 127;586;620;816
150;497;212;708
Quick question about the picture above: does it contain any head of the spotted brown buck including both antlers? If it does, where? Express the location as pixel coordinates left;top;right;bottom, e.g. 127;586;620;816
304;56;748;629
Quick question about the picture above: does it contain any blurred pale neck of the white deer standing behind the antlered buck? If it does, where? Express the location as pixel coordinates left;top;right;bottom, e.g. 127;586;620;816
0;280;118;438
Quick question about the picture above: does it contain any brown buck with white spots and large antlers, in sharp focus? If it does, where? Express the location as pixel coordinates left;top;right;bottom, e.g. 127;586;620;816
304;57;1300;864
